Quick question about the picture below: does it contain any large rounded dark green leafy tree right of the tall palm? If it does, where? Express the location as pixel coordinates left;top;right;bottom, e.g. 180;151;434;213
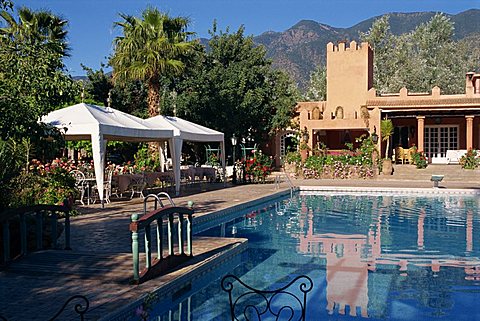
175;24;298;142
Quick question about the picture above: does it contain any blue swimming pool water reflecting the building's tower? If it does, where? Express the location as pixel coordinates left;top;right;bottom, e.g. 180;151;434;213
151;194;480;321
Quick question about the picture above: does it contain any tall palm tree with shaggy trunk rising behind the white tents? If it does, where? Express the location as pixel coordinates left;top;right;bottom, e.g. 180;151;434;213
110;8;194;117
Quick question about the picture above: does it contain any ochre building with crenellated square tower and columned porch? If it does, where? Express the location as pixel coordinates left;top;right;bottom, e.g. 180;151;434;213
296;41;480;164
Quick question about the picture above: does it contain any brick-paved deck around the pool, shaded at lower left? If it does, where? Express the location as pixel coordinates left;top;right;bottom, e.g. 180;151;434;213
0;171;480;321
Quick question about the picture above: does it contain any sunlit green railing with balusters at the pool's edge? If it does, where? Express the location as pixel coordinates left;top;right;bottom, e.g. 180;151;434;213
130;200;193;283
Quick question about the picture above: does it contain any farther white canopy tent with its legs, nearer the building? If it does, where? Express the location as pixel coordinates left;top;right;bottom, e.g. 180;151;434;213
145;115;226;193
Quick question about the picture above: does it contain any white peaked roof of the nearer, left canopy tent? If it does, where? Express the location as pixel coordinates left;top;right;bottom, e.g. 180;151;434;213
42;103;173;141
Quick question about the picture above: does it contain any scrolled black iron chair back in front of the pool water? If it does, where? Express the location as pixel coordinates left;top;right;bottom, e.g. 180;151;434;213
221;275;313;321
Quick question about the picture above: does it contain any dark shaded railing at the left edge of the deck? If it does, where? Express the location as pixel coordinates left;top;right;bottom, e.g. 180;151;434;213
0;200;71;264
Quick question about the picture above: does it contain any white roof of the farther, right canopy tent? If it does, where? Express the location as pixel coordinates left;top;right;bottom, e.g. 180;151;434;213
145;115;223;142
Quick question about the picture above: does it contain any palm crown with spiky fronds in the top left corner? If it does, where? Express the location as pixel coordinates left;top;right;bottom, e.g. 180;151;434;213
0;7;69;57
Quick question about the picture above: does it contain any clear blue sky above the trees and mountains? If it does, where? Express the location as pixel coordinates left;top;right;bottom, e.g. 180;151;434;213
9;0;480;75
